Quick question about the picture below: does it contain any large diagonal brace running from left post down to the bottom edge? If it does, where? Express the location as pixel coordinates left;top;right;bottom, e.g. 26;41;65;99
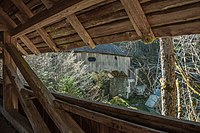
3;44;84;133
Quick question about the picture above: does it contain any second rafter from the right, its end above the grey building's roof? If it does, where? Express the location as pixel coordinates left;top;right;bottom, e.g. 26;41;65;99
67;14;96;48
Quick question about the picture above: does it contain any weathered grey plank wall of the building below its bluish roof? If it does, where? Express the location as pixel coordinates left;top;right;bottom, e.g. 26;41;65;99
76;53;130;76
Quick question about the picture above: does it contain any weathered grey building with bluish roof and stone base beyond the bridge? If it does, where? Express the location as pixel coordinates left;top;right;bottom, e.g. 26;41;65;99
74;44;131;98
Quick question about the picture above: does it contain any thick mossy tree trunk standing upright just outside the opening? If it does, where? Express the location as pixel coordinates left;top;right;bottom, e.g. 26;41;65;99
160;37;176;117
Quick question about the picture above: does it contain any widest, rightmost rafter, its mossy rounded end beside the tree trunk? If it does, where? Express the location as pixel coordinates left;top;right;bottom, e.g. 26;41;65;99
120;0;155;43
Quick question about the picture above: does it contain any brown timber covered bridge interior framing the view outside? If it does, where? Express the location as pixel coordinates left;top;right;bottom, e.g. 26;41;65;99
0;0;200;133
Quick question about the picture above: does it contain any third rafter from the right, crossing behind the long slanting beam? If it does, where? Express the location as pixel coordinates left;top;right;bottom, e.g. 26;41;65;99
12;0;59;52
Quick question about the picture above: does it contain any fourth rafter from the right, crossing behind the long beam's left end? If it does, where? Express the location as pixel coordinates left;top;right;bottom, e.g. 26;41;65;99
0;8;40;54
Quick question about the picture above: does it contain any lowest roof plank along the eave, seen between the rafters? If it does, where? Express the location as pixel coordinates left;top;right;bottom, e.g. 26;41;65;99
38;20;200;52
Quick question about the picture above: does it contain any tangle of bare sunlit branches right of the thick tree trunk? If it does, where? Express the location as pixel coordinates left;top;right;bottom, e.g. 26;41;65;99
174;35;200;121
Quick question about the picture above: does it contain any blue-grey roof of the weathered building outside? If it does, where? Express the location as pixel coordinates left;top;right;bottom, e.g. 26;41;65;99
73;44;131;56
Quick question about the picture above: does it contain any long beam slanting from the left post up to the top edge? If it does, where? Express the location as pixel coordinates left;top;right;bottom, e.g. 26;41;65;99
10;0;106;37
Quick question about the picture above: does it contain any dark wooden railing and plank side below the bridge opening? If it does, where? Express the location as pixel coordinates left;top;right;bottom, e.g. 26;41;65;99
1;83;200;133
